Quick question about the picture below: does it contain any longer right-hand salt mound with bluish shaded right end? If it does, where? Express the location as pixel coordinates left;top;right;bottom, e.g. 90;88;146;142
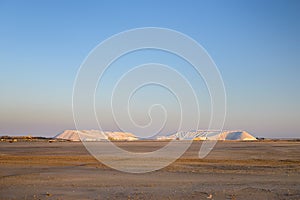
157;130;257;141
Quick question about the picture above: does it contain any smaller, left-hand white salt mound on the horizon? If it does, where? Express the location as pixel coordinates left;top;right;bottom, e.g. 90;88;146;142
55;130;138;141
